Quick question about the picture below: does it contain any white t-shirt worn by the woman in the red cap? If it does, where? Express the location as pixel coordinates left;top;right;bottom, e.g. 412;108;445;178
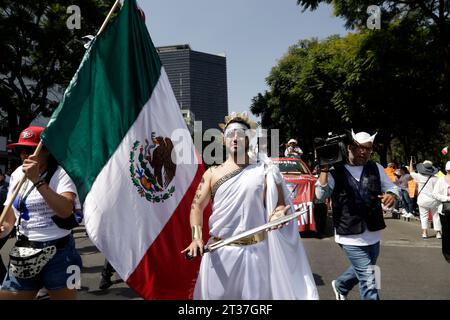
8;166;78;241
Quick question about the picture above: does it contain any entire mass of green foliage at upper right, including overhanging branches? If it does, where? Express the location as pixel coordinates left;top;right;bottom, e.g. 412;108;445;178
251;0;450;163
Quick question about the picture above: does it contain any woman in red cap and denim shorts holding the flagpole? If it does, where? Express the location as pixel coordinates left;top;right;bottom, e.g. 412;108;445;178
0;127;81;299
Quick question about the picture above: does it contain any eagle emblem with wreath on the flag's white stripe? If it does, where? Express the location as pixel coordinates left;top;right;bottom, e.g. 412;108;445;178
130;132;177;202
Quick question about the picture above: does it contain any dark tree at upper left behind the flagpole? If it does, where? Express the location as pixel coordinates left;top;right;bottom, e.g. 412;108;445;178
0;0;114;140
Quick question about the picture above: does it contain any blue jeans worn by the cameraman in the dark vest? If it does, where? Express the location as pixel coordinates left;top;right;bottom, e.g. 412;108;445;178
336;242;380;300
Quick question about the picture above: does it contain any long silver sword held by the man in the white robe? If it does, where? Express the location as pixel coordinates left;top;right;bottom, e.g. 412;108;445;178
184;208;309;260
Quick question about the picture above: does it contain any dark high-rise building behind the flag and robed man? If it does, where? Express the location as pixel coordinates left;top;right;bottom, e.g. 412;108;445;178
157;44;228;131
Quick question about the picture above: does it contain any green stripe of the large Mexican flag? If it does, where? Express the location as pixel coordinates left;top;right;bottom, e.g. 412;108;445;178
42;0;161;203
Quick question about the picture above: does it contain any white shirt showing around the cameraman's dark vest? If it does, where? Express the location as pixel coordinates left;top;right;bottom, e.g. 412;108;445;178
317;163;398;246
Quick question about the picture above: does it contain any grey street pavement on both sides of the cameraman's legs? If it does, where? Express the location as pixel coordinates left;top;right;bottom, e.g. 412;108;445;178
304;215;450;300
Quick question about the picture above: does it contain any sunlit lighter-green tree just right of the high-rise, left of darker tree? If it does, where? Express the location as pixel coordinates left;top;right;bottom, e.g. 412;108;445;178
251;35;360;160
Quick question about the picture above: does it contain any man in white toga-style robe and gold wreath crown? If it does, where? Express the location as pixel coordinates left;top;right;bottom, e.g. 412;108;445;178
183;114;318;300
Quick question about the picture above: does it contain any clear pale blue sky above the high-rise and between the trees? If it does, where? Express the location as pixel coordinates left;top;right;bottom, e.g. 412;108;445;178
138;0;347;120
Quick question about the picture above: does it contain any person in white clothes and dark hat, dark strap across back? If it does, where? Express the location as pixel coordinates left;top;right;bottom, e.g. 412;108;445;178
409;160;442;239
